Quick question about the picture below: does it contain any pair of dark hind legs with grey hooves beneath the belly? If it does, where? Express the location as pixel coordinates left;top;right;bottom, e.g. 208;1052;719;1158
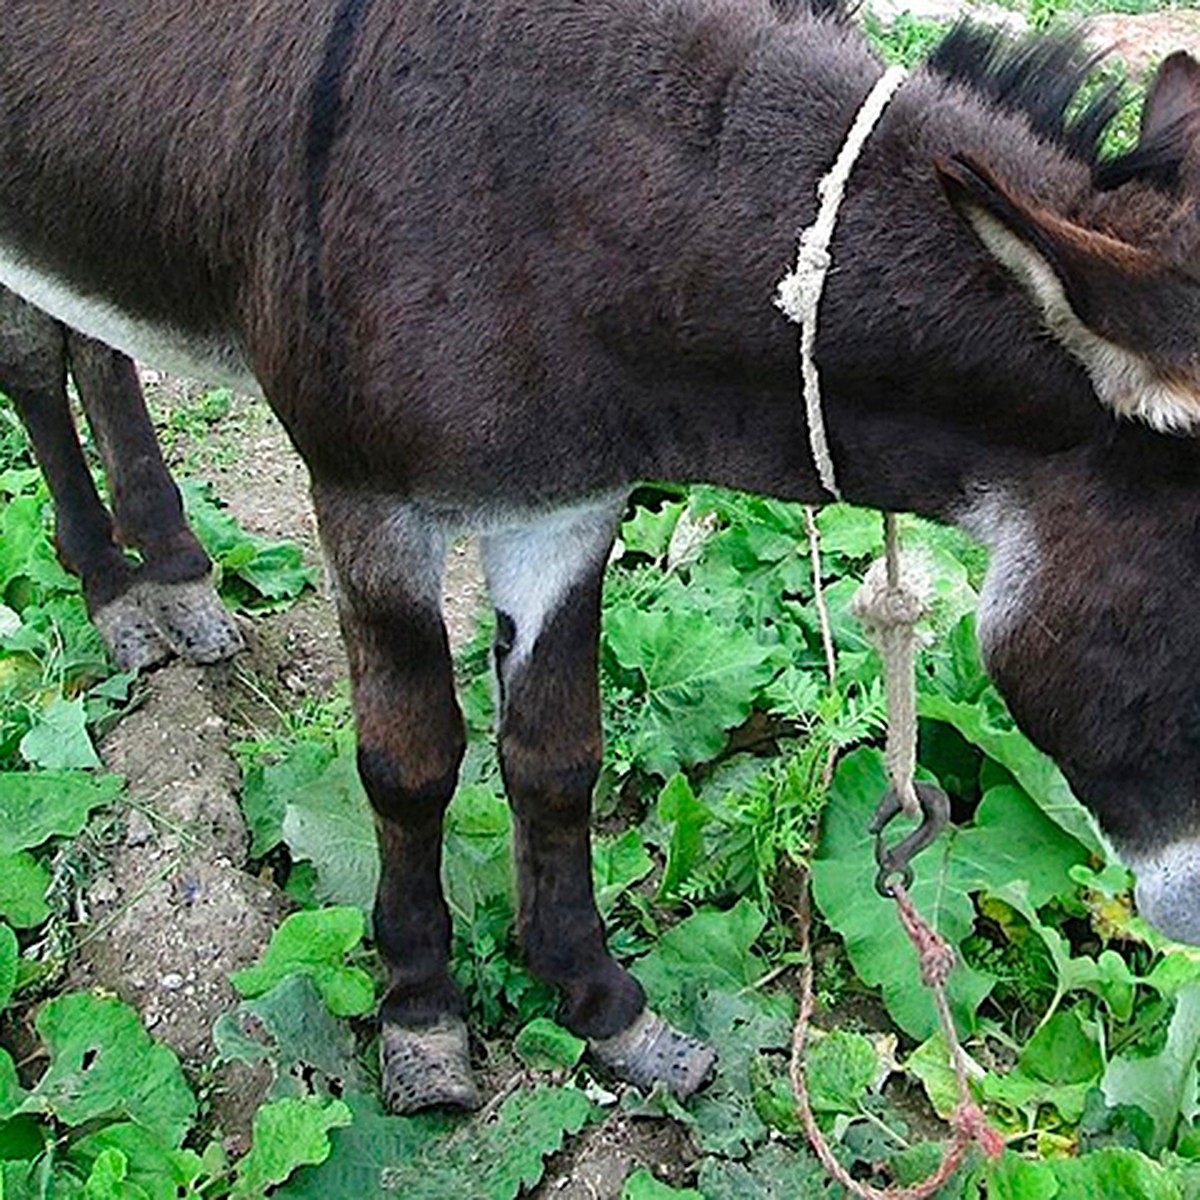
0;288;242;671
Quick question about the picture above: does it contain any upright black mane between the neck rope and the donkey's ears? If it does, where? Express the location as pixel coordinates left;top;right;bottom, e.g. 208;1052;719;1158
926;22;1186;191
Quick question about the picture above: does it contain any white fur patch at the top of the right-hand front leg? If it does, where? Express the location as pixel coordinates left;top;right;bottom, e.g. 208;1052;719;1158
481;493;625;676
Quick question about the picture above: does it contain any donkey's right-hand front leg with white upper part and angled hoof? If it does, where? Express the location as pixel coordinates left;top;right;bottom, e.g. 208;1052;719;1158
484;503;715;1098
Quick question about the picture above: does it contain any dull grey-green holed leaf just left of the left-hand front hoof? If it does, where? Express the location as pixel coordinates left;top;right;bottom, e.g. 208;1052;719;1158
212;974;358;1099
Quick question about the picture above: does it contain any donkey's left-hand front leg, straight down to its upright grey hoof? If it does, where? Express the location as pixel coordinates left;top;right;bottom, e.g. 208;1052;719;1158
313;487;479;1114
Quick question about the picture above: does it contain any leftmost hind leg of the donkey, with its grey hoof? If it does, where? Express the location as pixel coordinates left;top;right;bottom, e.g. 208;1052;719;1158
0;288;170;671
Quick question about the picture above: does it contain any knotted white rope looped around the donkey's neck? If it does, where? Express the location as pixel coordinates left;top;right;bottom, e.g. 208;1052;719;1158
775;67;907;500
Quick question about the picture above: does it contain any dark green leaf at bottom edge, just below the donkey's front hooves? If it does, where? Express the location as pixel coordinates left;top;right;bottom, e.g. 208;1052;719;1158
275;1087;593;1200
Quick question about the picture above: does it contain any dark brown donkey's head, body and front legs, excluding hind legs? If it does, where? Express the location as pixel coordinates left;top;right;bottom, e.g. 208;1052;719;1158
0;0;1200;1110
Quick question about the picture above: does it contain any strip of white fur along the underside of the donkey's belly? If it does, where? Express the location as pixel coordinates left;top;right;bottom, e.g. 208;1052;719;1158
0;246;259;394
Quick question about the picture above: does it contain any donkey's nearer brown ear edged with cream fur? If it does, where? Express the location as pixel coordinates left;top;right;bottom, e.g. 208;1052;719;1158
936;156;1200;430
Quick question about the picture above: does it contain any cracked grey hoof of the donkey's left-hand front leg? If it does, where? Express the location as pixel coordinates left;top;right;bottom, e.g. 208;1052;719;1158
379;1018;479;1116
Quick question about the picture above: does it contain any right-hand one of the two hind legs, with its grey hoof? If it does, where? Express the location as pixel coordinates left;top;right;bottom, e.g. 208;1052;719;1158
67;330;242;662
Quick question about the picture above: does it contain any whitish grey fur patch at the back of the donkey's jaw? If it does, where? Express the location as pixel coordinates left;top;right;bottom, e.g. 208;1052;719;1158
955;488;1042;654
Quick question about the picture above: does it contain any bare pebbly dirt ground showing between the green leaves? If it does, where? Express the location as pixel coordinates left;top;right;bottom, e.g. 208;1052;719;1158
63;9;1200;1200
